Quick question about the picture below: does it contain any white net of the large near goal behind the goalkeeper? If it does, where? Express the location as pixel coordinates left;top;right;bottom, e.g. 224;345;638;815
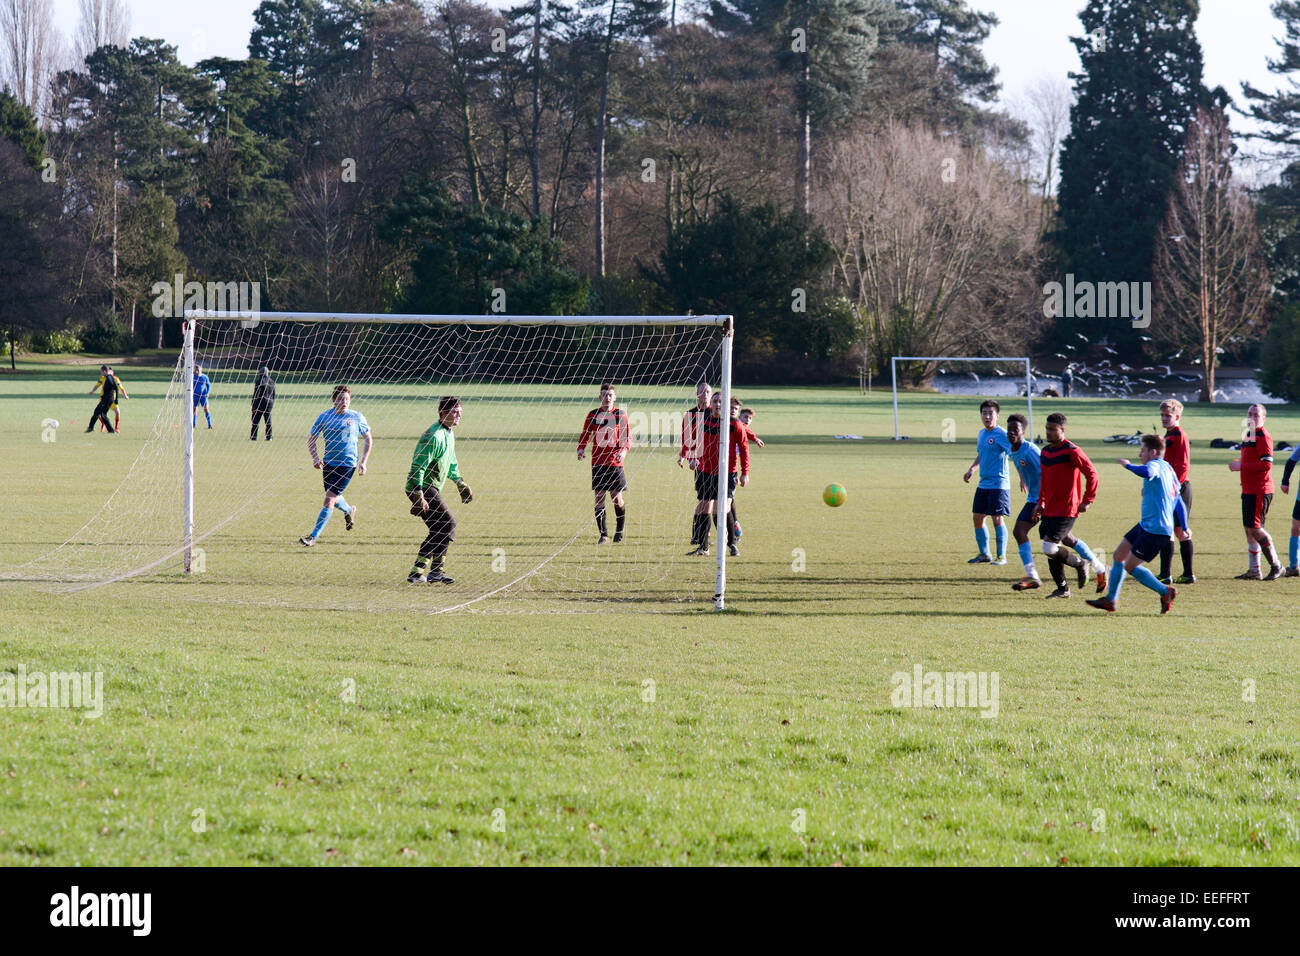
5;313;732;611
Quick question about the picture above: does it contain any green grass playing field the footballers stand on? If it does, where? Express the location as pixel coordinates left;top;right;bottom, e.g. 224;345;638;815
0;362;1300;866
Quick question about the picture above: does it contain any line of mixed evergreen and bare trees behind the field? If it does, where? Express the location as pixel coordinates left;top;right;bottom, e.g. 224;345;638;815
0;0;1300;394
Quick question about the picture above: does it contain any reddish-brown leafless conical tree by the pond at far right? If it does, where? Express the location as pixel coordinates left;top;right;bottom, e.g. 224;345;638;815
1152;108;1271;402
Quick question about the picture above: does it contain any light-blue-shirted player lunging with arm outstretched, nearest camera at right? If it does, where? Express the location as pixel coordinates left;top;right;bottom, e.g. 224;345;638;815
1087;434;1191;614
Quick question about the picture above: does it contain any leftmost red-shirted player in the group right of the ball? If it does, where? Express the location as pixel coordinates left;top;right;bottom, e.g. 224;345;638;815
1035;412;1106;597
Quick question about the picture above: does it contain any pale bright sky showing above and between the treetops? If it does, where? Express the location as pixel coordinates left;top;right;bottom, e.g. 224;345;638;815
45;0;1281;167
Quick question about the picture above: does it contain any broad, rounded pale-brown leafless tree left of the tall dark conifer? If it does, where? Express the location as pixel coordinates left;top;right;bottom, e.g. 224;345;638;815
815;124;1043;381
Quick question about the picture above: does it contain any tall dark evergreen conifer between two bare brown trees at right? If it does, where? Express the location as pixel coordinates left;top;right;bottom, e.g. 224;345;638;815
1056;0;1206;356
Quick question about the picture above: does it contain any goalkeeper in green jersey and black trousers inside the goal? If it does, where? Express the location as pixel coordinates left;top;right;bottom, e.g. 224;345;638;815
406;395;475;584
